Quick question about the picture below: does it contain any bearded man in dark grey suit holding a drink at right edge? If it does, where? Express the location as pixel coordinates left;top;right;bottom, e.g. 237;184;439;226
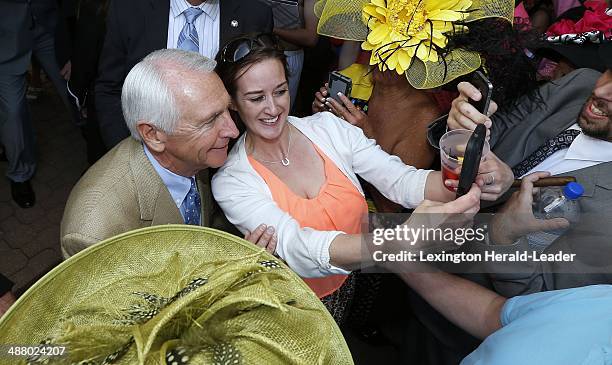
448;44;612;296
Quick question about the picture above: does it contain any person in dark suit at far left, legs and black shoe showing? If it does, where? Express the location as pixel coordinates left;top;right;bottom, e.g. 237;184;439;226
0;0;74;208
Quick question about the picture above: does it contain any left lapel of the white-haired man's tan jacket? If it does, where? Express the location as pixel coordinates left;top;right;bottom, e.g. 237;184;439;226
130;140;183;225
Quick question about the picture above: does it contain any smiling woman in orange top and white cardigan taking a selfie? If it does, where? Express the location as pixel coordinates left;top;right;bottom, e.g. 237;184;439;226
210;34;492;323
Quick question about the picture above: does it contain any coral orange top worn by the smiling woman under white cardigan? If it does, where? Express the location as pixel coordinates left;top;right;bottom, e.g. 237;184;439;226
249;144;368;298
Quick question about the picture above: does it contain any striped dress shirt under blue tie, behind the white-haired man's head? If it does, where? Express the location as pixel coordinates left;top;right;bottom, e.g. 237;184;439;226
167;0;221;59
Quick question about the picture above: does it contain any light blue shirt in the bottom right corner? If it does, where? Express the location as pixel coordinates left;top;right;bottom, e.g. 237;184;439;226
461;285;612;365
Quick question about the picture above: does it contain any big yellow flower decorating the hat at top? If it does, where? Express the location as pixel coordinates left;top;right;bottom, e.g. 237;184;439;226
362;0;472;74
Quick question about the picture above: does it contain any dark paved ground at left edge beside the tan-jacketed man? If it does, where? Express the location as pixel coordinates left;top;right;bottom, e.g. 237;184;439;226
0;79;87;293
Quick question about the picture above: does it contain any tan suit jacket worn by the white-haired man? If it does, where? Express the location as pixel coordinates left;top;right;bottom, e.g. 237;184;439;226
60;137;238;258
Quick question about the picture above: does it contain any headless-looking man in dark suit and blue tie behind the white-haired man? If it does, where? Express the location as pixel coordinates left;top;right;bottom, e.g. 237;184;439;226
96;0;273;148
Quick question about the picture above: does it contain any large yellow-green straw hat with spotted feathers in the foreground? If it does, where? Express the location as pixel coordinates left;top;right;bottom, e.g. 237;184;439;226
0;225;353;365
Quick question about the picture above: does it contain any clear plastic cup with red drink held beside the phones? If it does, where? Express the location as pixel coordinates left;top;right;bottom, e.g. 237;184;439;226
440;129;490;191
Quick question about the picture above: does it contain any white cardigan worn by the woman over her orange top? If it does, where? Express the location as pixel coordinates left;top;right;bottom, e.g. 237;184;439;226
212;112;431;277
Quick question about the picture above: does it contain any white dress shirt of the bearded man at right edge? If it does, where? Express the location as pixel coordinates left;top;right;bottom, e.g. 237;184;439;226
523;123;612;176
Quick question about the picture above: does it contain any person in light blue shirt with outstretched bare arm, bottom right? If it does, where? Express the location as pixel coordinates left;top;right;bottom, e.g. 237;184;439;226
401;273;612;365
